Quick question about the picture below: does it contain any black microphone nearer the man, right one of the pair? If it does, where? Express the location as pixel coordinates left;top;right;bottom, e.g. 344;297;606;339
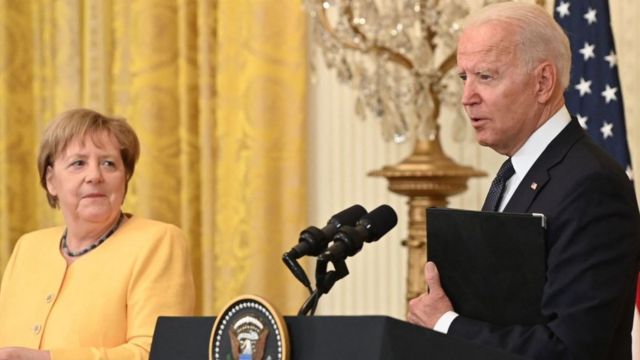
318;205;398;261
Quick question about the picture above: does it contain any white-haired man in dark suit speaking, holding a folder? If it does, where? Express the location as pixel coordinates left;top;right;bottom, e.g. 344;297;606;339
407;2;640;360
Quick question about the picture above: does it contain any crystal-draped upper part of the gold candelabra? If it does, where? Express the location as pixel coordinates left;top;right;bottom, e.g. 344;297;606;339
305;0;478;143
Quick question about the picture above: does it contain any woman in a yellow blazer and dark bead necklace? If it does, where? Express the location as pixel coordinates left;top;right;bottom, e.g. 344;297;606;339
0;109;194;360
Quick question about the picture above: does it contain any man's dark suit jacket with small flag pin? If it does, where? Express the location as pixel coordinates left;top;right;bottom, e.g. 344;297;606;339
449;119;640;360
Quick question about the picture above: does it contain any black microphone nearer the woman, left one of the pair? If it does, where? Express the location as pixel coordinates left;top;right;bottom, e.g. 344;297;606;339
285;204;367;259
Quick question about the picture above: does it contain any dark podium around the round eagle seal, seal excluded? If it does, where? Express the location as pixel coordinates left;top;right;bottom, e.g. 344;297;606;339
150;316;522;360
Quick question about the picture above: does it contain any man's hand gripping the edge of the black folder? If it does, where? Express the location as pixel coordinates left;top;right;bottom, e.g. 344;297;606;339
407;262;453;329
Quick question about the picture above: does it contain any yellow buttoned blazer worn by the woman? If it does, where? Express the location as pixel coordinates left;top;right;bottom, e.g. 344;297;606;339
0;216;195;360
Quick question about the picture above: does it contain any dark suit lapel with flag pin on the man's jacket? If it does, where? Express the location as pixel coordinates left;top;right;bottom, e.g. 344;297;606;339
504;118;585;213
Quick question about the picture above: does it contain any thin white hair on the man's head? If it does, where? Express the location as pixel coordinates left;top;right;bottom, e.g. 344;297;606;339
464;1;571;90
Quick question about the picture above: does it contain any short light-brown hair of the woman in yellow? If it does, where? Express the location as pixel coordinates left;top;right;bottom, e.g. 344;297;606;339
38;109;140;208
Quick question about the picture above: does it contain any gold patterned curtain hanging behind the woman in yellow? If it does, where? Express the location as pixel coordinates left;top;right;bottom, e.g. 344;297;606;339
0;0;307;314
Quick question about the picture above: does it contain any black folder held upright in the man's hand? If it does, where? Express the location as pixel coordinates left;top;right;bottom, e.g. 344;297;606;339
427;208;546;325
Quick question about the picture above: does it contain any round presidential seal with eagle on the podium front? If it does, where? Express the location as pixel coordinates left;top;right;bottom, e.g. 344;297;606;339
209;295;289;360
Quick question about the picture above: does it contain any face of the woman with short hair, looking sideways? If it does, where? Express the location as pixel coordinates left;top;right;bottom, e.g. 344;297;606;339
47;133;126;226
